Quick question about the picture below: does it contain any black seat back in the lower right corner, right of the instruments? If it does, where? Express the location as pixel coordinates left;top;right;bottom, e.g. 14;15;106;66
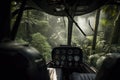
95;53;120;80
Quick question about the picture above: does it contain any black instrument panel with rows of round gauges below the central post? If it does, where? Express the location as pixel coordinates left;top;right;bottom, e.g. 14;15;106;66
52;47;83;68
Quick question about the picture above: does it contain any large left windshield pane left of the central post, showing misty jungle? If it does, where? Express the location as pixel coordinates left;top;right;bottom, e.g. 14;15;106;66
16;10;68;61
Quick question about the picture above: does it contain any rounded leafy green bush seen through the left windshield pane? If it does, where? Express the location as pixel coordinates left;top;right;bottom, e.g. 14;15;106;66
31;33;51;61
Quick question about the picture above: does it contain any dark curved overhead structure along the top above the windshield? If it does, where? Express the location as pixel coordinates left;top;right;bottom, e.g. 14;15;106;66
32;0;110;16
